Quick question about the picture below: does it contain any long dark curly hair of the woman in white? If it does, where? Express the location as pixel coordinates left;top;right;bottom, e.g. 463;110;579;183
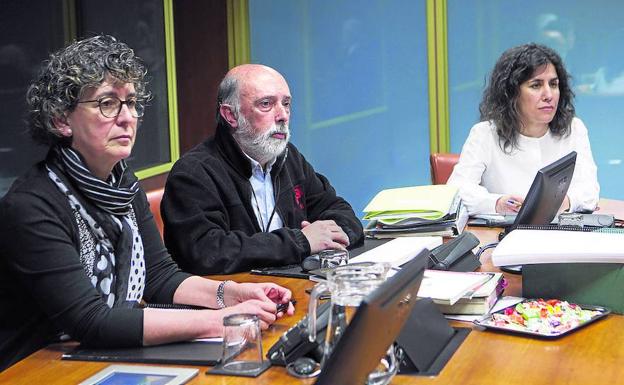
479;43;574;152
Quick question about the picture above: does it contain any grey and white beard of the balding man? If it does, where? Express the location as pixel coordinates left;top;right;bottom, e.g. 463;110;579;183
232;114;290;165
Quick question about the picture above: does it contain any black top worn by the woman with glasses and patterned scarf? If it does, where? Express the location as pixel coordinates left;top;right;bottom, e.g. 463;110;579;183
0;163;189;371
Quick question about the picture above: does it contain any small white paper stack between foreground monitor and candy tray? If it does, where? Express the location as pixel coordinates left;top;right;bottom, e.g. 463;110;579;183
418;270;492;306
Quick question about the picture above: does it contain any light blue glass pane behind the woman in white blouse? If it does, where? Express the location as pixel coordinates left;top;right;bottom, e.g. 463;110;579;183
448;0;624;199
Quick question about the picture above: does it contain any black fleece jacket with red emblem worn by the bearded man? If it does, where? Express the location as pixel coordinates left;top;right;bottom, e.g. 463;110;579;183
161;126;364;274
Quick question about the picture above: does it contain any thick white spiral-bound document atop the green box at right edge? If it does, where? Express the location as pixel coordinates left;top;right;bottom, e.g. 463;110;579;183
492;229;624;266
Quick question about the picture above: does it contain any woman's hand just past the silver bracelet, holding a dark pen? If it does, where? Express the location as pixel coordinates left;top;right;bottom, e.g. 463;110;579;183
224;282;295;318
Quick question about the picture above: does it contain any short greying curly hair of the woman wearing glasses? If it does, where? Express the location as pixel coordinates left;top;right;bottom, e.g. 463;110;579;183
26;35;150;146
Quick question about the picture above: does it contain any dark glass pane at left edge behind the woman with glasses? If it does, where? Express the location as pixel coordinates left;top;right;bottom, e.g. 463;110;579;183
0;0;63;197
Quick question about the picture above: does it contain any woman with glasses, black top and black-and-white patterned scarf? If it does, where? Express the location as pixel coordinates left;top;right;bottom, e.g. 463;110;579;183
0;36;294;370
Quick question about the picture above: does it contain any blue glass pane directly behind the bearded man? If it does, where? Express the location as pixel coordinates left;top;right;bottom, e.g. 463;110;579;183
249;0;429;216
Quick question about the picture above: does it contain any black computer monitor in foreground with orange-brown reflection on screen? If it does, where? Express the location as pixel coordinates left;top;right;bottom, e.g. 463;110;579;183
315;249;429;385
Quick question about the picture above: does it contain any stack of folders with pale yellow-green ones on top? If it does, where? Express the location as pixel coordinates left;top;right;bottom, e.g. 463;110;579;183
364;185;468;238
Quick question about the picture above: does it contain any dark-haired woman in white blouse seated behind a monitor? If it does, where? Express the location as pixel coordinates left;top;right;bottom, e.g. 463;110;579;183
448;44;600;215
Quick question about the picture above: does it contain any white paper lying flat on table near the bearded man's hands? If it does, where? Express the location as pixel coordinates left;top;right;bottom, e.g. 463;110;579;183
349;237;442;267
